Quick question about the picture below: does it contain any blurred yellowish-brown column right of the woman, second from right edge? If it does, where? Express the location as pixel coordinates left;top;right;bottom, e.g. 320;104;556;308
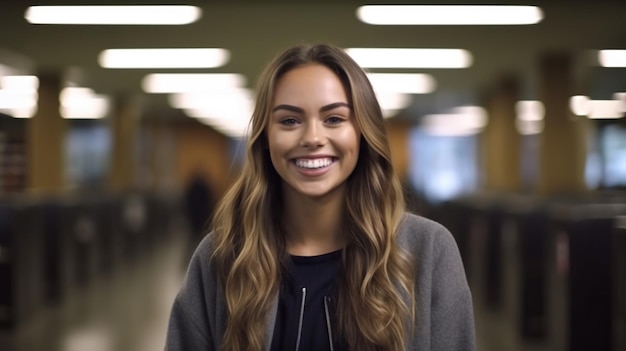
482;77;522;192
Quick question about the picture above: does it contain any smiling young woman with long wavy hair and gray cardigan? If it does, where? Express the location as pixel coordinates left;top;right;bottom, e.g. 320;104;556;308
166;45;474;351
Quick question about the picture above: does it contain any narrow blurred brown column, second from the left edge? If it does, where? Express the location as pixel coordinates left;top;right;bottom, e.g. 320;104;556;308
108;97;140;191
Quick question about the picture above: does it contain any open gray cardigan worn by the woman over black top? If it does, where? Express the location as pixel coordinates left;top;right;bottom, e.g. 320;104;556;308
165;214;475;351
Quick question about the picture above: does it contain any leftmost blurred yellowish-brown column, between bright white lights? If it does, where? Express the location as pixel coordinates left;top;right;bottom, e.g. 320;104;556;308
27;72;67;195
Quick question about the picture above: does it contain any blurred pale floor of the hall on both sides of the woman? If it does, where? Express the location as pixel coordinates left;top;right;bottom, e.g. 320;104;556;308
0;216;540;351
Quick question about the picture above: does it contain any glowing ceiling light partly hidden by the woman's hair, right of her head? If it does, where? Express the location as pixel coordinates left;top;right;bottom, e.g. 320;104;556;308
346;48;472;68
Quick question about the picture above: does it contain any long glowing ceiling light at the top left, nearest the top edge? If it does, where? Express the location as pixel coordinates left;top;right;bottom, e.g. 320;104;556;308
24;5;202;25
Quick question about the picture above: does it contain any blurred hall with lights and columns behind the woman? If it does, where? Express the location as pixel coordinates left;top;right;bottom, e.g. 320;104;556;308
0;0;626;351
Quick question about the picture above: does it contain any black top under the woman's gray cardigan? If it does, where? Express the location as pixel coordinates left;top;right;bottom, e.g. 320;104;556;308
271;250;343;351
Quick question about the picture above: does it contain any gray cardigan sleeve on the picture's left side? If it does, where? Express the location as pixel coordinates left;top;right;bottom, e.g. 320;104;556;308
165;239;215;351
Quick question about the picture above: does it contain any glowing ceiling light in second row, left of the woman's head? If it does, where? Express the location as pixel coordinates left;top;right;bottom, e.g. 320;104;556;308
98;48;230;68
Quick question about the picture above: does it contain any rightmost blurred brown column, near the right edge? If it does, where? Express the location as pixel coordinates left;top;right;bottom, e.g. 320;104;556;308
538;53;588;194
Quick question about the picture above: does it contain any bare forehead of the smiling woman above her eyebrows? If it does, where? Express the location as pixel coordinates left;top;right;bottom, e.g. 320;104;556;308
273;64;348;105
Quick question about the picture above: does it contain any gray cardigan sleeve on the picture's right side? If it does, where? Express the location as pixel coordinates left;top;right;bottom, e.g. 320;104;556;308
431;227;475;351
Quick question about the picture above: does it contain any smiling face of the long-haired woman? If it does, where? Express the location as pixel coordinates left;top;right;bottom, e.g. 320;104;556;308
267;64;361;201
